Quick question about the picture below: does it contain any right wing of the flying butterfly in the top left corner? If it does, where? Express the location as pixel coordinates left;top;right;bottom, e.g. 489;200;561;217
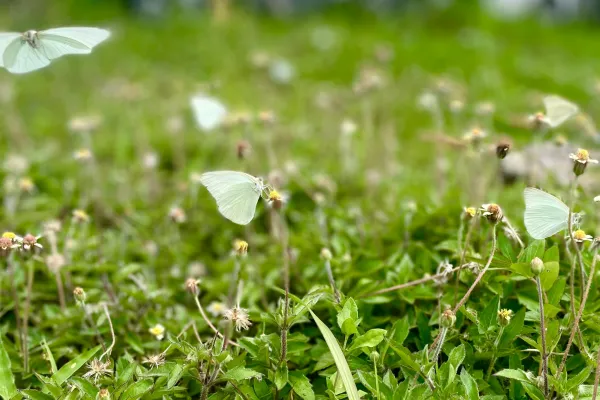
38;27;110;60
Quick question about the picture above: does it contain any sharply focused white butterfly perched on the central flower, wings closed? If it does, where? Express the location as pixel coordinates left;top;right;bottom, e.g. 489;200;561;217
200;171;268;225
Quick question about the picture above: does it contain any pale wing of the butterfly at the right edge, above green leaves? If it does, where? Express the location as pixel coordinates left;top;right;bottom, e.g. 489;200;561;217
524;188;569;239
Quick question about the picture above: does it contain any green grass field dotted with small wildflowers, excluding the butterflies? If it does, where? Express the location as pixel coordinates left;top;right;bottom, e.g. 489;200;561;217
0;1;600;400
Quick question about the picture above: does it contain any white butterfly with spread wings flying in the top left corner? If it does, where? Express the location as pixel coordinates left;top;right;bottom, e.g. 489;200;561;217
0;27;110;74
